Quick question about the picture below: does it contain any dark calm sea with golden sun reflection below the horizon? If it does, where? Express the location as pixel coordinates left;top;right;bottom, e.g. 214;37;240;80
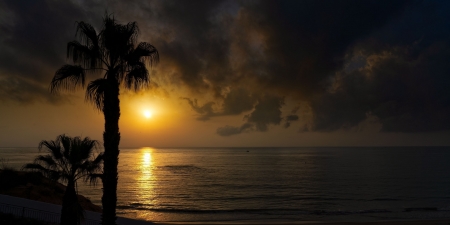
0;147;450;223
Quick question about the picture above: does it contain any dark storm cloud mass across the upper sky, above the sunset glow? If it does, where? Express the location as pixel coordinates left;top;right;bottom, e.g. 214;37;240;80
0;0;450;136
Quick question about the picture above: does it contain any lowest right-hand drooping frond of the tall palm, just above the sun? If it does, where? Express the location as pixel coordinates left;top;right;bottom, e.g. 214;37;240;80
124;62;150;91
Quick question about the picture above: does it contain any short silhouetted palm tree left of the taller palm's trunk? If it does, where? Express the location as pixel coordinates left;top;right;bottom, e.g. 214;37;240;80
23;134;103;225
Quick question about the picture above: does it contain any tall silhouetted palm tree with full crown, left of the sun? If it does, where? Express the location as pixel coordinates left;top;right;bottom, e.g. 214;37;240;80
50;14;159;225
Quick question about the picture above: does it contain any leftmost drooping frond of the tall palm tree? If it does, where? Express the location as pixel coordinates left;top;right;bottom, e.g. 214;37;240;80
50;65;86;93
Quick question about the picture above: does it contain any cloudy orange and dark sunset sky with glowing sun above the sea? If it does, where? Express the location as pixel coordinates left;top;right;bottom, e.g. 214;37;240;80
0;0;450;147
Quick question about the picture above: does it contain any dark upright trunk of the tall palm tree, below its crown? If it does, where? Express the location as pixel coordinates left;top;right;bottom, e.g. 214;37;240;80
102;76;120;225
